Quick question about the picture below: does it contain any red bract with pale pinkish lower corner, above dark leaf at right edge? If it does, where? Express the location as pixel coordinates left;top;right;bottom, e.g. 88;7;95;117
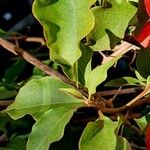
134;21;150;47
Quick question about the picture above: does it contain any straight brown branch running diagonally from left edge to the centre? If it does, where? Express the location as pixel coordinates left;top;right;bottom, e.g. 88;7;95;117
0;38;88;97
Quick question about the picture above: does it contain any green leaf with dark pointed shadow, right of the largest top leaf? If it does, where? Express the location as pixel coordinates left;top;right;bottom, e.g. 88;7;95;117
88;0;137;51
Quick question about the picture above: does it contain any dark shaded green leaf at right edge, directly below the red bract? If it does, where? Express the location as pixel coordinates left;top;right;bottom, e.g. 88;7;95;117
136;48;150;78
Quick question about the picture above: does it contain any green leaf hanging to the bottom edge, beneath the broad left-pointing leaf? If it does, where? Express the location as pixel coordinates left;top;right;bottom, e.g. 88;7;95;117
27;105;80;150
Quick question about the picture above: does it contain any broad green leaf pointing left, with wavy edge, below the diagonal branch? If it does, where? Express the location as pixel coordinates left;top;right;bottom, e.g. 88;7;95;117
5;77;83;119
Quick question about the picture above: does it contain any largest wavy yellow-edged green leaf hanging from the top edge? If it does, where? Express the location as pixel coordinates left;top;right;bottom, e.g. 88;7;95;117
33;0;96;66
